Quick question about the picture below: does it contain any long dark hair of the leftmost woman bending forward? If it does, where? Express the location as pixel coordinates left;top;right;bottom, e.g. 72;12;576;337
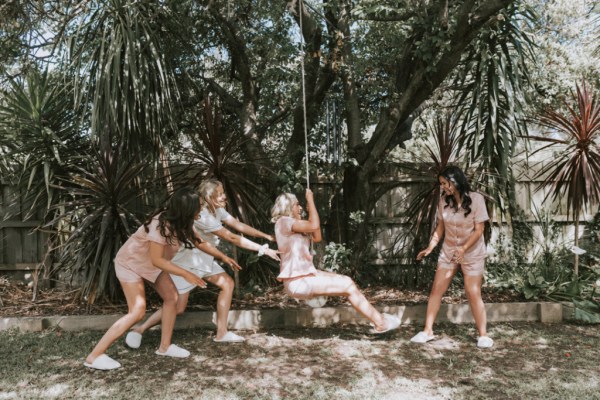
144;187;201;249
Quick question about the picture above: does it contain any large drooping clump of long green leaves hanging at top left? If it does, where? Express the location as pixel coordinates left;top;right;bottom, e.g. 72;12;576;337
64;0;177;155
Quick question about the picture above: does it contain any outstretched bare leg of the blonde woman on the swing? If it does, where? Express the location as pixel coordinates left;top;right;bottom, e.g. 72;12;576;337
307;271;386;330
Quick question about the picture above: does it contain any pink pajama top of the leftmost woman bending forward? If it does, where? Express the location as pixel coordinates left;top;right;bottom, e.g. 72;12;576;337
115;216;179;278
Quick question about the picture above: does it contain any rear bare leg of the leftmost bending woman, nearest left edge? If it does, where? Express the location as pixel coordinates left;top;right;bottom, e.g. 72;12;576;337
85;282;146;363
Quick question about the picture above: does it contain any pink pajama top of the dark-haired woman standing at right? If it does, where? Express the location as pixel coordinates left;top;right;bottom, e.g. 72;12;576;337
438;192;489;264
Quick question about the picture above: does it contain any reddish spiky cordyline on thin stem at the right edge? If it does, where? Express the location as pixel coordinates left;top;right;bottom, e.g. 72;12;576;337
528;82;600;275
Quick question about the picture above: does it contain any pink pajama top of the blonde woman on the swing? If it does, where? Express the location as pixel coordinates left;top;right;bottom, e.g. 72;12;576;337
275;217;317;281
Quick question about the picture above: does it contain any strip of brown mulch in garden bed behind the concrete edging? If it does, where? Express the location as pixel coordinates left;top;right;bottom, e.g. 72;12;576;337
0;277;526;317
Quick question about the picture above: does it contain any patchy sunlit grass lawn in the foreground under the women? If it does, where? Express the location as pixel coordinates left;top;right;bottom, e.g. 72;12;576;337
0;323;600;400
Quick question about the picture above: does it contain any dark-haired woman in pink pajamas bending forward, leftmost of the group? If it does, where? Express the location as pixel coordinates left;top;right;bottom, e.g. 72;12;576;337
84;188;239;370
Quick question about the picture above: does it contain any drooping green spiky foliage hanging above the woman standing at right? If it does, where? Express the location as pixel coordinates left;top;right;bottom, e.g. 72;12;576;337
454;3;537;217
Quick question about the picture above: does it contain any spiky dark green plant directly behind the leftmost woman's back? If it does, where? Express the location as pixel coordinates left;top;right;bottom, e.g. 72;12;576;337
48;150;151;304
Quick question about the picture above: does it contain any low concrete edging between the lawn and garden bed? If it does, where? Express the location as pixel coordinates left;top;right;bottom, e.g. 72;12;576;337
0;302;571;332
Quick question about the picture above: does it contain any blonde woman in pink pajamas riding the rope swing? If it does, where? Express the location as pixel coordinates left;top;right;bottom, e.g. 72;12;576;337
271;189;400;333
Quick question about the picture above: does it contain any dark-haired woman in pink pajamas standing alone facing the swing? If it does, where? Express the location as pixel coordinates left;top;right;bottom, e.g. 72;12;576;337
411;166;494;348
